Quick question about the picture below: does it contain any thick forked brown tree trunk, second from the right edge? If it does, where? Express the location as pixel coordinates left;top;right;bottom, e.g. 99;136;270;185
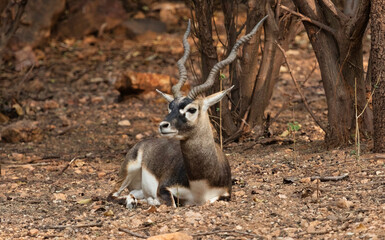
293;0;371;147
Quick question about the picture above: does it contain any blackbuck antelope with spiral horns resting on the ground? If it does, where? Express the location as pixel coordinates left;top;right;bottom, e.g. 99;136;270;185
109;17;266;208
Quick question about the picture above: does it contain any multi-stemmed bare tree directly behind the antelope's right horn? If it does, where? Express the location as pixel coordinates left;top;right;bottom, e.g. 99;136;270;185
186;0;298;142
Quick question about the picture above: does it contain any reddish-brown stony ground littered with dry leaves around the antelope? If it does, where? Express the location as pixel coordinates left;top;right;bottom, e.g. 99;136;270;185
0;17;385;239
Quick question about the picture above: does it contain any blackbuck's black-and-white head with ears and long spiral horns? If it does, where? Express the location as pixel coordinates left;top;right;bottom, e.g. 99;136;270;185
156;16;267;140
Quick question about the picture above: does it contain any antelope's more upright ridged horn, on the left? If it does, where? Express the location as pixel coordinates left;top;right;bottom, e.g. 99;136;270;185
171;19;191;98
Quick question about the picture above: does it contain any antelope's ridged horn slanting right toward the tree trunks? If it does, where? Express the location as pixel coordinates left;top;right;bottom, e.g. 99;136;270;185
187;15;267;99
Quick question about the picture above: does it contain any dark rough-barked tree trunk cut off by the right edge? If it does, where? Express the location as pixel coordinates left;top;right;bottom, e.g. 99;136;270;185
370;0;385;152
